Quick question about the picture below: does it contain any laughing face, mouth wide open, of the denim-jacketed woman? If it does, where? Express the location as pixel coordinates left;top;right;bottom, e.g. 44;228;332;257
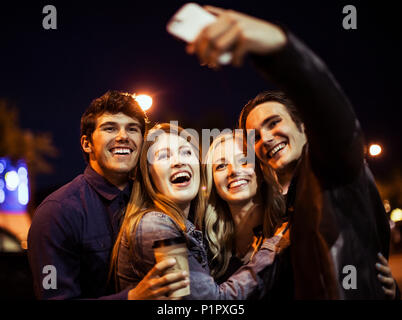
148;133;200;206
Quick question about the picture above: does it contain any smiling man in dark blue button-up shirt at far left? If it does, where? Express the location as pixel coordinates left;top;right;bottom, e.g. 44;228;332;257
28;91;188;299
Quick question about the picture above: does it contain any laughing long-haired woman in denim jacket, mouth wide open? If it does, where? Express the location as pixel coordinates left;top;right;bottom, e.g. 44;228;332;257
112;124;288;299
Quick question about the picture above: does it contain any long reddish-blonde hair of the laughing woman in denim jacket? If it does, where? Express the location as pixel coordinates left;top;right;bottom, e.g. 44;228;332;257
109;123;206;284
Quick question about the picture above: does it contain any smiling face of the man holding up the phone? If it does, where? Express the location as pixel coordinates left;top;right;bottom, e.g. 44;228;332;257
246;101;307;174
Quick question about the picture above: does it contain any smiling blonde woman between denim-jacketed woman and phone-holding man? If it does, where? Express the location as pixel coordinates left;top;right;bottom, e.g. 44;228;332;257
198;133;287;282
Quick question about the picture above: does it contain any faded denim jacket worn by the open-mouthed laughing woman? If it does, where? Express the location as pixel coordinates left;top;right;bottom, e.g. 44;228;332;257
117;211;283;300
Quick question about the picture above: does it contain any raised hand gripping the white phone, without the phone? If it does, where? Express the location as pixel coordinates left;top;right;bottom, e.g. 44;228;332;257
187;6;286;67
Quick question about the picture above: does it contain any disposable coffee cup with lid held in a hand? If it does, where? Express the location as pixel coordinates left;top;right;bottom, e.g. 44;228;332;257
152;237;190;298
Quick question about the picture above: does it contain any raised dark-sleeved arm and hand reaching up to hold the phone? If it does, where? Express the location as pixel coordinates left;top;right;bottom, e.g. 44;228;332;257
188;7;364;179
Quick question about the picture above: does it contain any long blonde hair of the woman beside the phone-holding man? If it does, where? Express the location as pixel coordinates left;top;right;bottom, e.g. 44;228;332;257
197;132;285;278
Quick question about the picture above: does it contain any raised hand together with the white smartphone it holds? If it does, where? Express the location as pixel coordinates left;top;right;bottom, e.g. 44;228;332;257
167;3;287;66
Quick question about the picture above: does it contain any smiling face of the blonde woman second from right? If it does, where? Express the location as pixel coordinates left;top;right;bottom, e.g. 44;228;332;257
212;138;258;204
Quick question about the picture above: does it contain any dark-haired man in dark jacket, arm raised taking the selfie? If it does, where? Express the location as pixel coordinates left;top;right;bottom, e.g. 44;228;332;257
187;6;399;299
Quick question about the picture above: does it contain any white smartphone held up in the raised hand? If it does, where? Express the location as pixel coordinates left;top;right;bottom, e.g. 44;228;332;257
166;2;232;65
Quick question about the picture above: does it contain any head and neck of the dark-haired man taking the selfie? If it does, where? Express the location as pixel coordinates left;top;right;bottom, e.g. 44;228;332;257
240;92;307;194
